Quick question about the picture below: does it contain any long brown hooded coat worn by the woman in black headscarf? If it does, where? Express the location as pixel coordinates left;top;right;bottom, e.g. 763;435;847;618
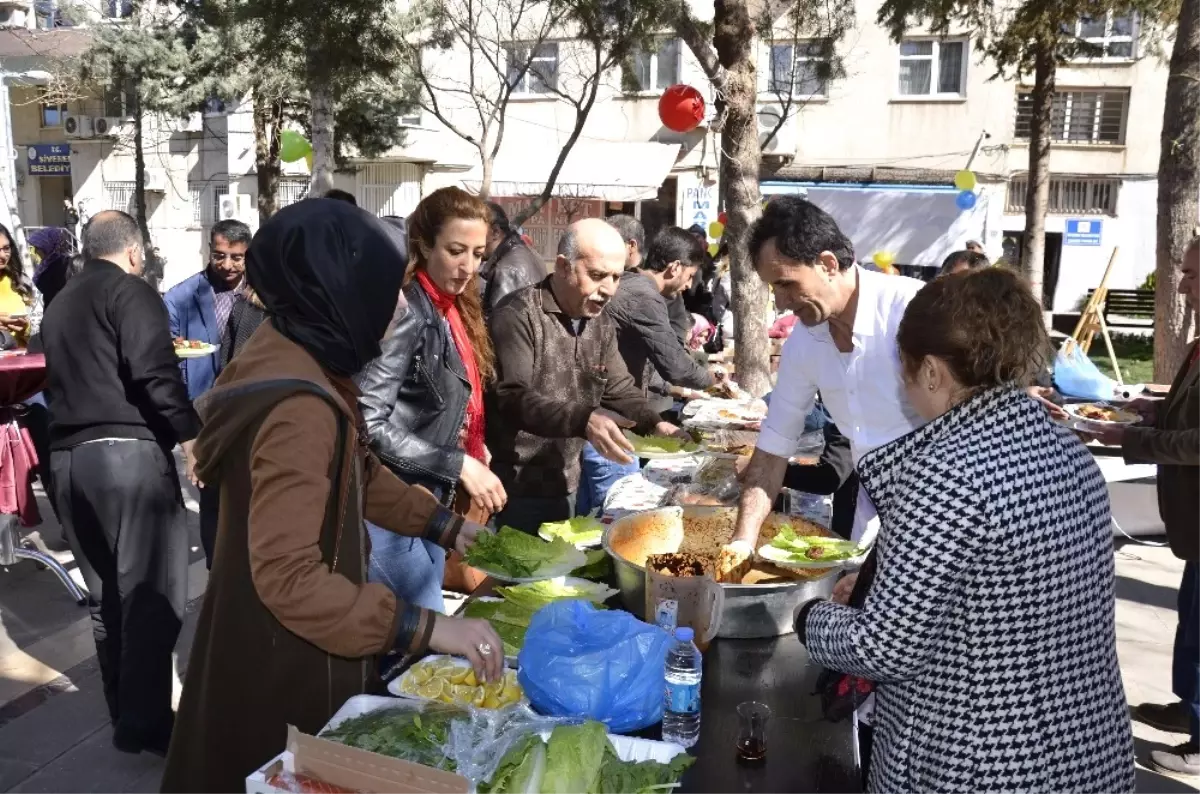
162;324;461;794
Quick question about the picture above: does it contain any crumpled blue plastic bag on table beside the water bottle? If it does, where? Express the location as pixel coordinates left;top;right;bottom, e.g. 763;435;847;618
517;600;671;733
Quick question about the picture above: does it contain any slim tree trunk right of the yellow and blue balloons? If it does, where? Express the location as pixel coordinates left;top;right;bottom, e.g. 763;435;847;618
1021;43;1057;311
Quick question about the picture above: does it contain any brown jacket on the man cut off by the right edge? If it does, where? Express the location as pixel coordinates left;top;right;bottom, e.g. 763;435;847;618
1122;342;1200;561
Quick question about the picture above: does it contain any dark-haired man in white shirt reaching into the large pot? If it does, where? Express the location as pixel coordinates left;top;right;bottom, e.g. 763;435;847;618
722;196;924;565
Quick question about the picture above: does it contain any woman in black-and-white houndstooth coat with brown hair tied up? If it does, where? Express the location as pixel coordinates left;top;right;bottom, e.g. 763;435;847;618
797;269;1134;794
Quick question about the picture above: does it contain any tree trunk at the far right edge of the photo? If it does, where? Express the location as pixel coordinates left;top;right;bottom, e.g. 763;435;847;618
1154;0;1200;384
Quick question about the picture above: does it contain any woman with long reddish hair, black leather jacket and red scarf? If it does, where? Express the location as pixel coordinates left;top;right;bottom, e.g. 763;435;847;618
358;187;506;628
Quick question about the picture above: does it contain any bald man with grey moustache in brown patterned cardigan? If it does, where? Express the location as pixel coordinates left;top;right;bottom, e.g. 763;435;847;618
486;218;680;533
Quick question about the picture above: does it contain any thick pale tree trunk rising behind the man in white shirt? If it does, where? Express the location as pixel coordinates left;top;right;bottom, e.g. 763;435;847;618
713;0;772;397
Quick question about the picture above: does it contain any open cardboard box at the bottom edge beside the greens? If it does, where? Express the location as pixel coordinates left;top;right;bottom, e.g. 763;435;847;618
246;726;470;794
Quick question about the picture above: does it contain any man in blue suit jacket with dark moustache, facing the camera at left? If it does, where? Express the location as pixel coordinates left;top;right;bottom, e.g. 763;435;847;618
163;221;253;399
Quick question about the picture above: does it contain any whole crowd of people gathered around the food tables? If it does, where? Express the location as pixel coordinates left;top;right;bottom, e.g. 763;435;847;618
7;187;1200;794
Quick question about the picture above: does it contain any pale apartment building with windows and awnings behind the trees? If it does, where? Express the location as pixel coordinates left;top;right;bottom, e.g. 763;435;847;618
0;0;1166;311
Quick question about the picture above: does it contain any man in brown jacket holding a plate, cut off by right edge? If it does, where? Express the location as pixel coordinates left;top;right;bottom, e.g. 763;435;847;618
1098;240;1200;777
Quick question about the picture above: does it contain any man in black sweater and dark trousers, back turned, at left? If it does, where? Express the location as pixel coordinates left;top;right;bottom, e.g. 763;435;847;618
42;211;199;754
